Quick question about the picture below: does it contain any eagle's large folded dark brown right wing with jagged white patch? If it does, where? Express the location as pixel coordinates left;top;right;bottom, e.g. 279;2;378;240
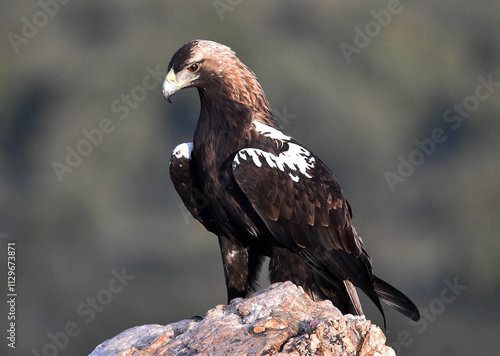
232;142;383;314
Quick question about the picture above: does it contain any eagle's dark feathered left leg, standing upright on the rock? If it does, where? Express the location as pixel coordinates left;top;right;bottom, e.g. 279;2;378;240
219;236;262;303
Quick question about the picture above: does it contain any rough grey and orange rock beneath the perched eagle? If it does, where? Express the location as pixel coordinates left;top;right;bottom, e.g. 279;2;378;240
90;282;395;356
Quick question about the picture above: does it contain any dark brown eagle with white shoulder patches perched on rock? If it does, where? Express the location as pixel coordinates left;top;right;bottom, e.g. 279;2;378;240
162;40;420;325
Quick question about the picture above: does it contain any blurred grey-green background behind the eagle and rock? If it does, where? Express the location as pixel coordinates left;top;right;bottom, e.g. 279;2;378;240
0;0;500;355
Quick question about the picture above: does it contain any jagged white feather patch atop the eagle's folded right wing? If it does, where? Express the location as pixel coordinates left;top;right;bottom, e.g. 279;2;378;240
233;143;316;182
